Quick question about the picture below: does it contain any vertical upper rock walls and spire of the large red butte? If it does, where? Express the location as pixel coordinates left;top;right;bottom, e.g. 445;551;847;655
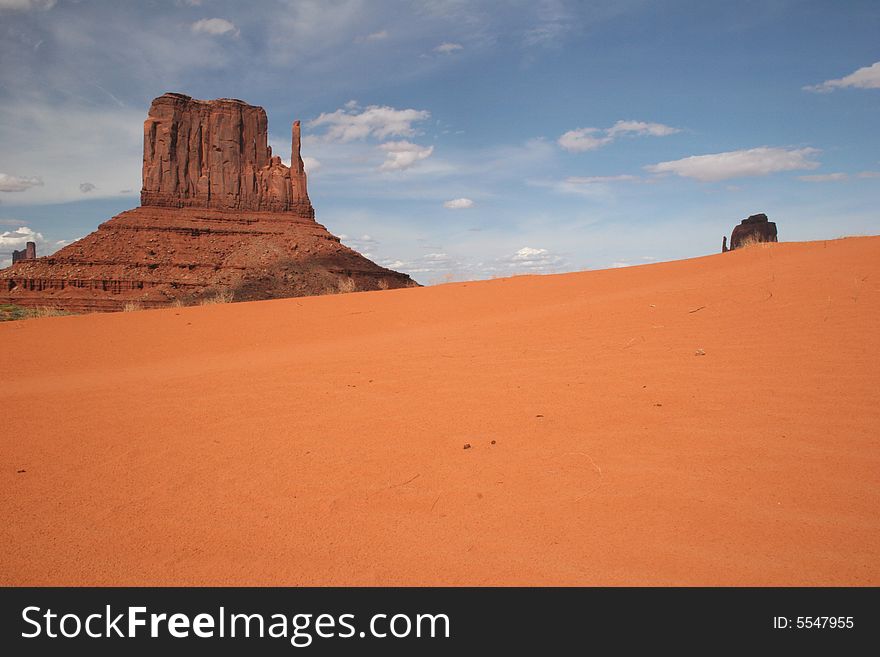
141;94;314;216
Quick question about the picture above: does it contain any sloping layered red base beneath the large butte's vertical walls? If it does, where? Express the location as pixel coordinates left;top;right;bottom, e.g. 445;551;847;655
0;207;415;312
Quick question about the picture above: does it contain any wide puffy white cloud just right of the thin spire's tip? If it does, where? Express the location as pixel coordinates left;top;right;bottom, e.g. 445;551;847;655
308;101;431;142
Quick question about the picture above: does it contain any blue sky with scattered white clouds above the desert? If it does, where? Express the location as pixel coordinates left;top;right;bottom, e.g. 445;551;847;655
0;0;880;284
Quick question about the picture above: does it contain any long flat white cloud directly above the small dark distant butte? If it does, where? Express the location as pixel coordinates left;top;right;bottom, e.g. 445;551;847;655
645;146;819;182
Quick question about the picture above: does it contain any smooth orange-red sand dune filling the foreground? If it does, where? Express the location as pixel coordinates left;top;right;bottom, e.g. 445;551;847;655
0;237;880;585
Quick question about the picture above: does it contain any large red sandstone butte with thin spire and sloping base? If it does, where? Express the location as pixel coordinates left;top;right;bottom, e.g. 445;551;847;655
0;93;416;312
